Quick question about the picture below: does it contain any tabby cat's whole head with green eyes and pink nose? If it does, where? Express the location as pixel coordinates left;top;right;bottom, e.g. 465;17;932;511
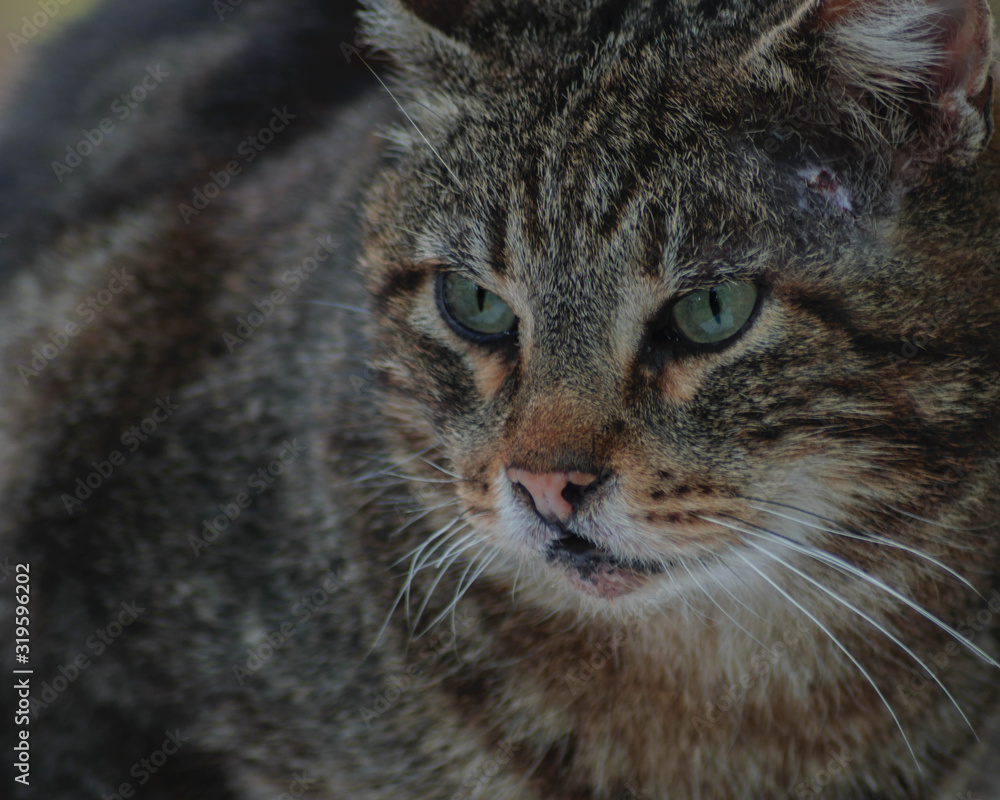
362;0;1000;607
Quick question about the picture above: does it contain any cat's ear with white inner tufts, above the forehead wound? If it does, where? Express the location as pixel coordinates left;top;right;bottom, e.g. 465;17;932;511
782;0;996;189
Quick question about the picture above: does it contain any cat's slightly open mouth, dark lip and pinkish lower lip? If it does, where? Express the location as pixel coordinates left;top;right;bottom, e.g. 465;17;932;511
545;525;663;598
